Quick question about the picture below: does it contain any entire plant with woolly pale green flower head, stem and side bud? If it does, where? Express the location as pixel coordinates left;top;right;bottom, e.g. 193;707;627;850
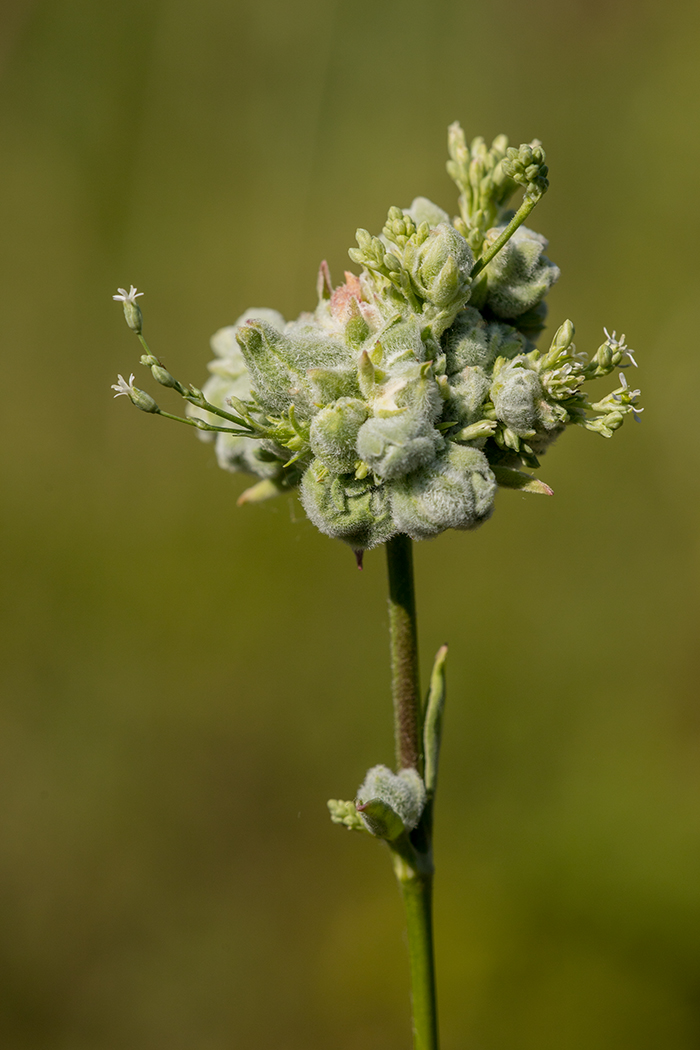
113;124;642;1050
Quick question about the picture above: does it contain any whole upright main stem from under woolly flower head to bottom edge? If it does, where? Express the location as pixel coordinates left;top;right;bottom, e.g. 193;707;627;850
386;536;439;1050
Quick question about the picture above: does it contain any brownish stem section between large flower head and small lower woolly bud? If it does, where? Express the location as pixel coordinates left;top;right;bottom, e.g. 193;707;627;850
386;536;423;773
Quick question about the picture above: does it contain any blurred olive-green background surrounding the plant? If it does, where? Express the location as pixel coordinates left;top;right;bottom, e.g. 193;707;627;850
0;0;700;1050
